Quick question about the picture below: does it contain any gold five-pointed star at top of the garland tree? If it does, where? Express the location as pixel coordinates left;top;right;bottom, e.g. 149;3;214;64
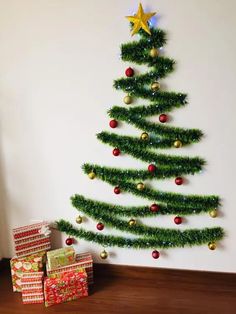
126;3;156;36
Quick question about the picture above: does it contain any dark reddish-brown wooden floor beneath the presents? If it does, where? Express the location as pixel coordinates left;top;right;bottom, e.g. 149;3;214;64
0;265;236;314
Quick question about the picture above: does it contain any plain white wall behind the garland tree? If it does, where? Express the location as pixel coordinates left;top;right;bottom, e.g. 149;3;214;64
0;0;236;272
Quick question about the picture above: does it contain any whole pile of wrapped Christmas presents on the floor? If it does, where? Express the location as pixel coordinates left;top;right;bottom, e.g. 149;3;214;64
10;222;93;306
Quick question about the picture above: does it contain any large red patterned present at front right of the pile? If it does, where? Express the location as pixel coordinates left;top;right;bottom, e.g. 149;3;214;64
44;270;88;307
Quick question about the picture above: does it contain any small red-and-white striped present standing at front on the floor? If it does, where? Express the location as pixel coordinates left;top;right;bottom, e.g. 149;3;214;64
21;271;44;304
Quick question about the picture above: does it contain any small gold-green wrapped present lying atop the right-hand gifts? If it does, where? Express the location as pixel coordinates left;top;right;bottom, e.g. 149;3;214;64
47;247;75;270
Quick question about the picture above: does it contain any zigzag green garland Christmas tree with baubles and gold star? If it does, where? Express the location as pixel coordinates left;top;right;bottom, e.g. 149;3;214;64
57;5;224;258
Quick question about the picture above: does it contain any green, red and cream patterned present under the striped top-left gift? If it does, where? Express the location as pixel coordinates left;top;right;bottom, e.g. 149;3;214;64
10;252;46;292
